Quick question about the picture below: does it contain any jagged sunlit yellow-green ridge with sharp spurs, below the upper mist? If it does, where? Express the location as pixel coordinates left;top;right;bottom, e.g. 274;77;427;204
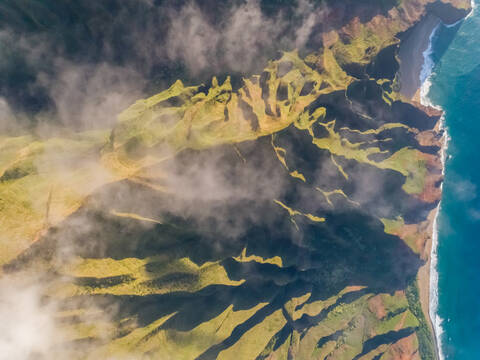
112;52;347;156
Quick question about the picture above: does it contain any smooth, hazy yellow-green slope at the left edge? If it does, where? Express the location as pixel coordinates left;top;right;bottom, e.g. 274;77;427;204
0;132;110;264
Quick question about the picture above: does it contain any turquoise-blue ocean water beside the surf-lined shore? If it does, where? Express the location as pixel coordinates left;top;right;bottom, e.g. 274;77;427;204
428;0;480;360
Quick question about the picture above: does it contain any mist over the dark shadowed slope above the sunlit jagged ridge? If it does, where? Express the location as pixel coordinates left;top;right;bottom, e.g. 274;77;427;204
0;0;326;130
